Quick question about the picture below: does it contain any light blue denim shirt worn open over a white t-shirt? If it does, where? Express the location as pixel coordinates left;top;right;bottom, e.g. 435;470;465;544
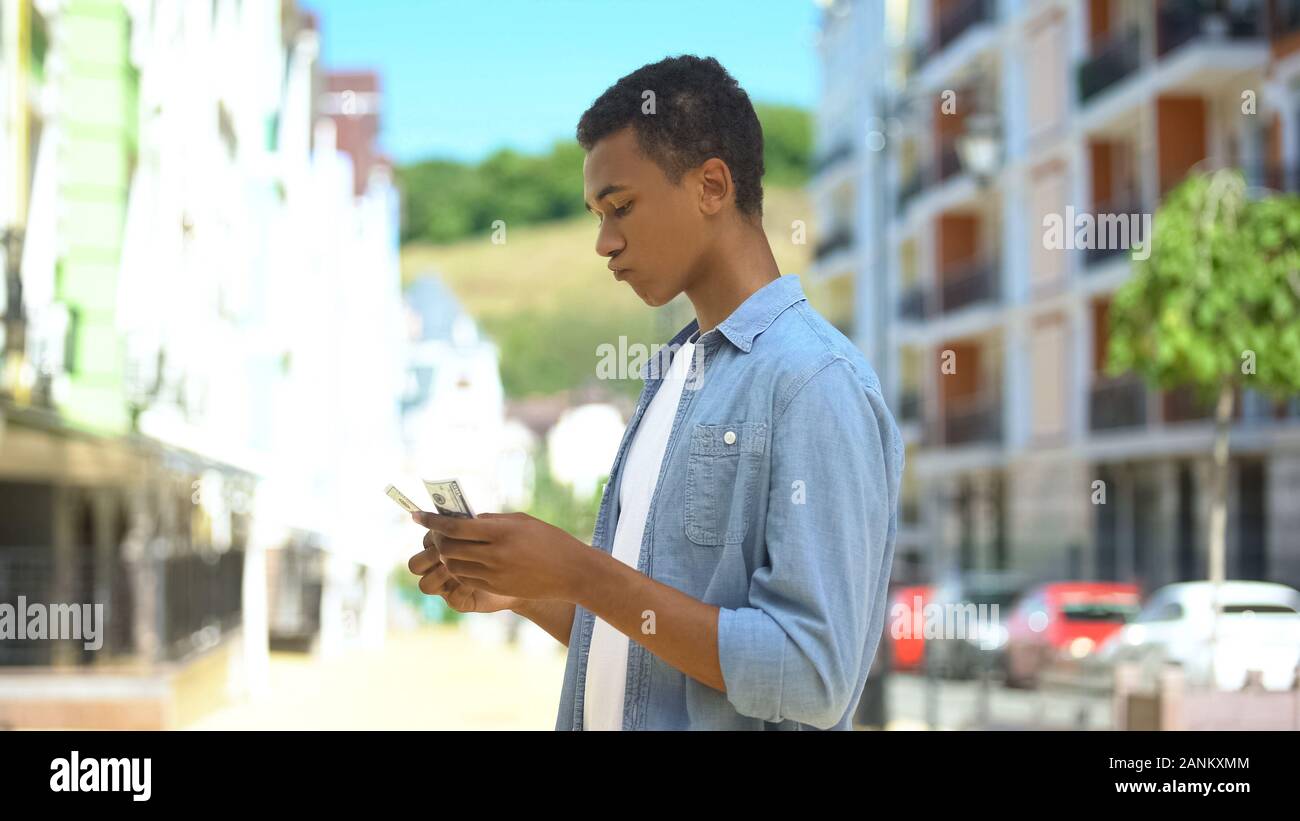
555;274;904;730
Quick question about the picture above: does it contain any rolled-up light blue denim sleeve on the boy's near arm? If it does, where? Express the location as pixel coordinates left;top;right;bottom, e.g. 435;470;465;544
718;357;902;729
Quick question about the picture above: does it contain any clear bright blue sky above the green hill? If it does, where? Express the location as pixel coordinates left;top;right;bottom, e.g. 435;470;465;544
303;0;818;162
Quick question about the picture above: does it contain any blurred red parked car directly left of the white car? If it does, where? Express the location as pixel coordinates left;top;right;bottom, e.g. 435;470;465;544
1002;582;1141;687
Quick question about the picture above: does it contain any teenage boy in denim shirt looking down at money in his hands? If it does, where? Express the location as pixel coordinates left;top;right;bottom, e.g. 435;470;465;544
410;56;904;730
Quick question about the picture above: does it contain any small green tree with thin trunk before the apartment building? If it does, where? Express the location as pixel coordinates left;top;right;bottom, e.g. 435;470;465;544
1108;169;1300;680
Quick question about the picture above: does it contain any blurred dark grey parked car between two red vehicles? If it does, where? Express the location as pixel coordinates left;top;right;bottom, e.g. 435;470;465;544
924;572;1024;679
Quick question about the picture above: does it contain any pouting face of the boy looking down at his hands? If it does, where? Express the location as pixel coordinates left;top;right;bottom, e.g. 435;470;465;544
582;126;707;307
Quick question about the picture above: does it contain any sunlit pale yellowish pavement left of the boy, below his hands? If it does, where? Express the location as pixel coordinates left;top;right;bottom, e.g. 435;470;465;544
186;625;564;730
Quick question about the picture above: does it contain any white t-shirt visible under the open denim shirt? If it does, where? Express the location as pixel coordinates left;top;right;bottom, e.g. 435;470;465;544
582;331;699;730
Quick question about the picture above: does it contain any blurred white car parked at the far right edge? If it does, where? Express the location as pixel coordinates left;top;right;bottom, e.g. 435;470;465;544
1099;582;1300;690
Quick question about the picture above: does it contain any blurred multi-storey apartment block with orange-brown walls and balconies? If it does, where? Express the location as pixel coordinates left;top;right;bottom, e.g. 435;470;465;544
814;0;1300;597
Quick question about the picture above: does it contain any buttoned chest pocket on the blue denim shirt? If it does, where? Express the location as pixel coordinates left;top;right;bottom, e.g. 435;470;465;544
685;422;767;547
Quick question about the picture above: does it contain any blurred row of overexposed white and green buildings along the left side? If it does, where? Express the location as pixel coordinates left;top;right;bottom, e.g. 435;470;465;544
0;0;403;726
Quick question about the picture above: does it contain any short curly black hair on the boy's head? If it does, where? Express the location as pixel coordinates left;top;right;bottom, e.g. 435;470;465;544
577;55;763;217
